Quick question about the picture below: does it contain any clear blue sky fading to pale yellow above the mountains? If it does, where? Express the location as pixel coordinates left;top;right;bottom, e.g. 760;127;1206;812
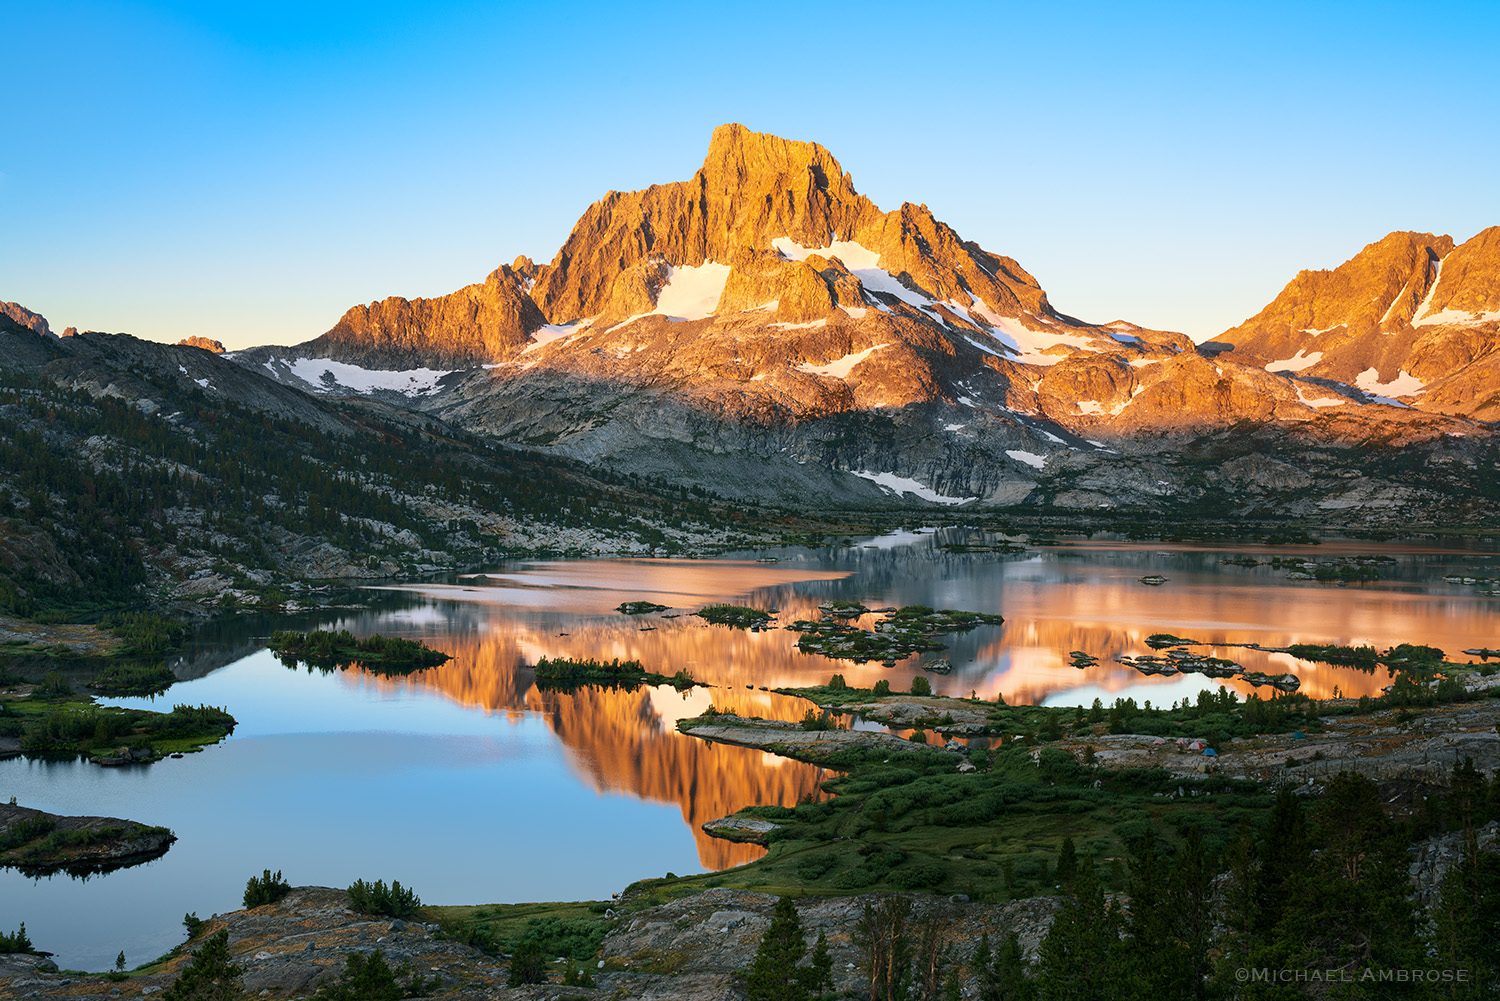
0;0;1500;347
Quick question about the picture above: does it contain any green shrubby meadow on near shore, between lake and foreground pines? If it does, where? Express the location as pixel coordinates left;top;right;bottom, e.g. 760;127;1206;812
626;744;1272;903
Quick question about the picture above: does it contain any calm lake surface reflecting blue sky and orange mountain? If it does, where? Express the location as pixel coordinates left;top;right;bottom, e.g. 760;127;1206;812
0;530;1500;969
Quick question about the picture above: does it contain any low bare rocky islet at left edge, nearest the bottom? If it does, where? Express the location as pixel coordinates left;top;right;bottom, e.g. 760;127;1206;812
0;803;177;875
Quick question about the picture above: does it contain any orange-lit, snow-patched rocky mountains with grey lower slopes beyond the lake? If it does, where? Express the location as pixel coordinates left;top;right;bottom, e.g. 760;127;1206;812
225;125;1500;521
